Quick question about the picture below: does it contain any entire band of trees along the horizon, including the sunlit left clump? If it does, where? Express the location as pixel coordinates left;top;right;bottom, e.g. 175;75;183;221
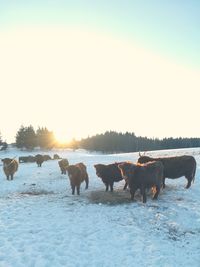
0;129;200;153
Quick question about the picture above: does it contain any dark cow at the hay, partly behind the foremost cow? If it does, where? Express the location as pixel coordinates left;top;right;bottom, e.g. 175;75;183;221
94;162;127;192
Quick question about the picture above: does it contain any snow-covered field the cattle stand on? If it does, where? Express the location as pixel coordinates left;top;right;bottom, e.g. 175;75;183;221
0;148;200;267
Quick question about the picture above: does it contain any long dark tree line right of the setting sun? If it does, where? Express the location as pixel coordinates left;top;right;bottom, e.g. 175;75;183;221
79;131;200;153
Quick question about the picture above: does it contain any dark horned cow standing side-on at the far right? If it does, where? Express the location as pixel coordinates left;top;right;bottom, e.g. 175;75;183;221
138;155;196;189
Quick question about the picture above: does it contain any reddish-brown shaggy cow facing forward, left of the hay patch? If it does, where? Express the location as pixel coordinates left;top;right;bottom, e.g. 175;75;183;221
67;162;89;195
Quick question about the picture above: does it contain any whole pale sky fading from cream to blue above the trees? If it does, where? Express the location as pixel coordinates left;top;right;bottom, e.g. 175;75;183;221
0;0;200;142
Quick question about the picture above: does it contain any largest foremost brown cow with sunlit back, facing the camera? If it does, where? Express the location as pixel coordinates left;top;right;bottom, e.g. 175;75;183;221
118;161;164;203
